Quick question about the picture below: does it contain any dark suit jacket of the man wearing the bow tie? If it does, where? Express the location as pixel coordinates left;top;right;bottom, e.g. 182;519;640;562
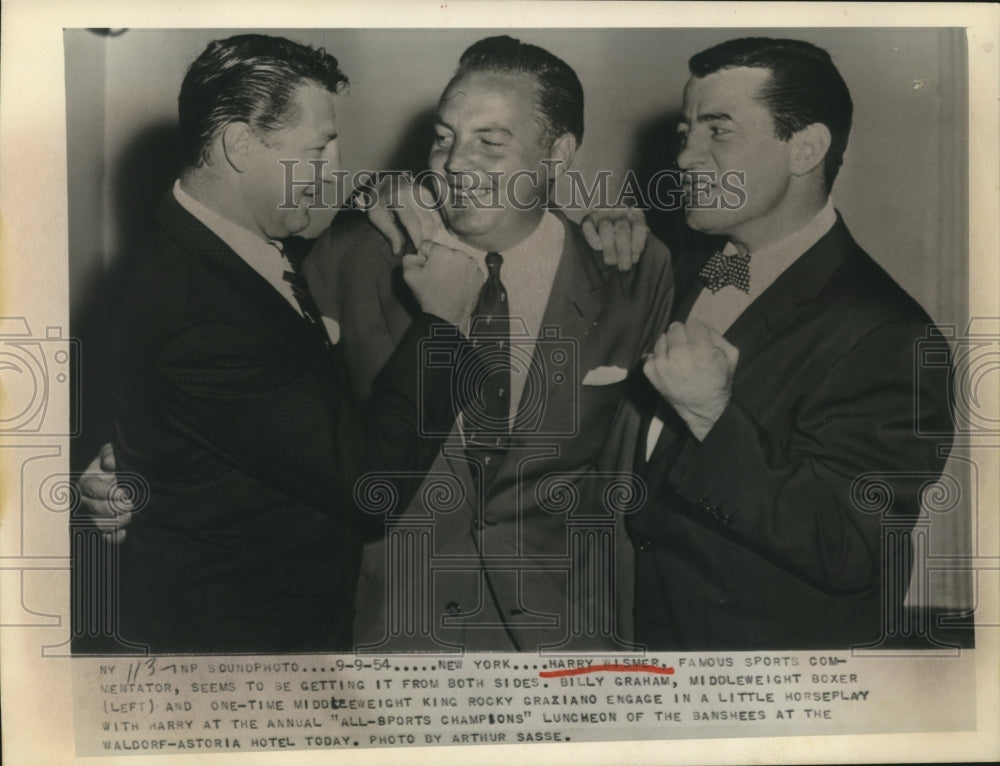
630;218;950;650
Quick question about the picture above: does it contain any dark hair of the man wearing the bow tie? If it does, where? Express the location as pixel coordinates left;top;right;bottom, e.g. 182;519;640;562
688;37;854;192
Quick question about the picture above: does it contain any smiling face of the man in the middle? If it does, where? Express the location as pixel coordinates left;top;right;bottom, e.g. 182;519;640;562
428;72;552;251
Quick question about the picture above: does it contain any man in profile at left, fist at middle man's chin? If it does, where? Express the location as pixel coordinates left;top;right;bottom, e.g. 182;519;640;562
105;35;482;653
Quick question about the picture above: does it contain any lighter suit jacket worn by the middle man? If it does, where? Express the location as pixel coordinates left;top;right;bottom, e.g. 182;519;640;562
305;214;673;651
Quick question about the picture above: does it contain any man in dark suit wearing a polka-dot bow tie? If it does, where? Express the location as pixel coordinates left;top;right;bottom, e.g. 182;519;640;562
630;38;950;650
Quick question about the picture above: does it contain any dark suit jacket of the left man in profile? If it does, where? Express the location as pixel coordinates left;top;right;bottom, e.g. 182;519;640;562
114;195;453;653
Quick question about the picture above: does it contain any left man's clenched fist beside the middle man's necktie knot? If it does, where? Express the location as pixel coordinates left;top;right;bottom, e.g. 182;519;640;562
403;240;486;327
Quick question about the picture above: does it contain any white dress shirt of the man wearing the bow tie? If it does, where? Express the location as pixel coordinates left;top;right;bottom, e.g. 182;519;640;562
646;200;837;460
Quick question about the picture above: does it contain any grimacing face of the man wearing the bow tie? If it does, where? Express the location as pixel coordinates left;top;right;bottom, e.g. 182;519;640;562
677;67;795;250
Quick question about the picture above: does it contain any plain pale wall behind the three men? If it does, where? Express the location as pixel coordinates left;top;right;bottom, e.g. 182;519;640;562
65;29;968;603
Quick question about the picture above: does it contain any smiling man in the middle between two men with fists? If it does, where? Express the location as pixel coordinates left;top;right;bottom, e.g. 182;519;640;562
305;37;673;651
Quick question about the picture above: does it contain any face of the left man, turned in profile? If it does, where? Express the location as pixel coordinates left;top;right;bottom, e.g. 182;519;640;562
241;83;340;239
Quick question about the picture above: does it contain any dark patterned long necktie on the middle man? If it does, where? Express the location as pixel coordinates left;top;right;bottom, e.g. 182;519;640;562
459;253;510;486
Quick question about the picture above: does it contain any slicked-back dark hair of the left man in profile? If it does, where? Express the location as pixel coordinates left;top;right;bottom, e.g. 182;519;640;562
177;35;347;167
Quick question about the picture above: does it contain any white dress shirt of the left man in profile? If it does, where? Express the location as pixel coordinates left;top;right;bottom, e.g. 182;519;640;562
173;181;340;344
